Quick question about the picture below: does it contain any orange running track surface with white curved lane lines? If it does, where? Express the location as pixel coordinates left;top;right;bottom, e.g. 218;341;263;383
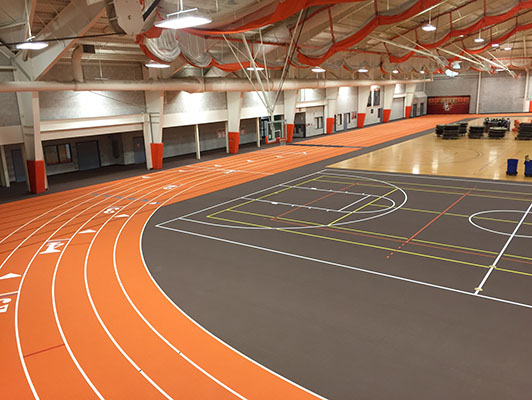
0;116;520;399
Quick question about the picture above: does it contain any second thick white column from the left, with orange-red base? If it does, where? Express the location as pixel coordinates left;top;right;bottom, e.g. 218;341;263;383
144;91;164;169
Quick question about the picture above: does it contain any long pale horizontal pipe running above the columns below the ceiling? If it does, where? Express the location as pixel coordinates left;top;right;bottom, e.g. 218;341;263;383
0;77;432;93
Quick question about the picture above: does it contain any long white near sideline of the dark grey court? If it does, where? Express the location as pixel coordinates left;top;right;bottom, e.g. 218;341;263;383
159;226;532;309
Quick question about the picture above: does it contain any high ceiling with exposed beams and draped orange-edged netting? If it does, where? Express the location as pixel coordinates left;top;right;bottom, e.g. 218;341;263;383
0;0;532;79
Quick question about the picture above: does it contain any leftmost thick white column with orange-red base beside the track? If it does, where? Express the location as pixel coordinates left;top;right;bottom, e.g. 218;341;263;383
17;92;48;193
